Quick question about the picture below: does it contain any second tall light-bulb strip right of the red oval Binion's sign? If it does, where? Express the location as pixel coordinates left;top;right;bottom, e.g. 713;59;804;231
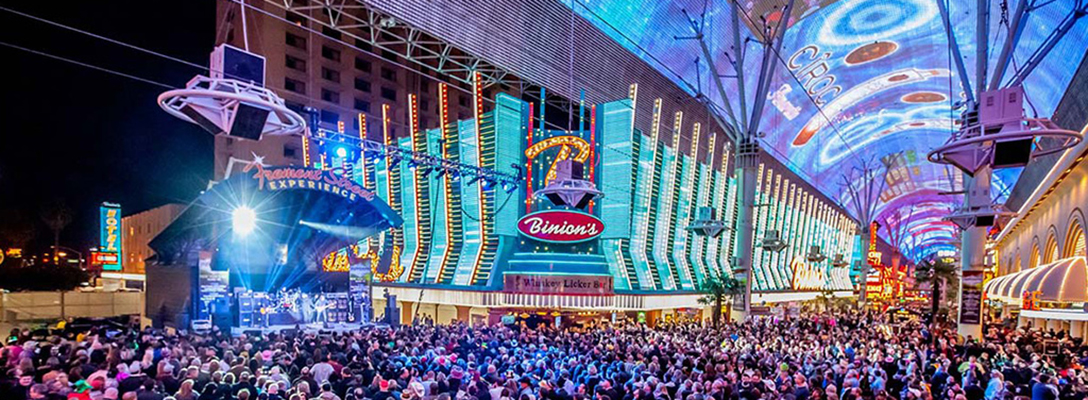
631;99;662;289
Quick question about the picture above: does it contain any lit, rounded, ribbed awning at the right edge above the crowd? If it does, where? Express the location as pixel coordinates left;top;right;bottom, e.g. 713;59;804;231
985;257;1088;302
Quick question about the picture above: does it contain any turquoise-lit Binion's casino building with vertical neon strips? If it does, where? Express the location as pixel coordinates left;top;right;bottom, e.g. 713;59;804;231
318;85;862;322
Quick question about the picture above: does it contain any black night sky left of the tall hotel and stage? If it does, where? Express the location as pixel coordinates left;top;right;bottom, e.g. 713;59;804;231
0;0;215;253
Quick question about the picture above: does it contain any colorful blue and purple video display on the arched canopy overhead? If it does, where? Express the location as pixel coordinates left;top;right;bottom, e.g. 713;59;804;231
568;0;1088;260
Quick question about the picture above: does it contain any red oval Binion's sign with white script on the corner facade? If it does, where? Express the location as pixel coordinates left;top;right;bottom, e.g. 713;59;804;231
518;210;605;243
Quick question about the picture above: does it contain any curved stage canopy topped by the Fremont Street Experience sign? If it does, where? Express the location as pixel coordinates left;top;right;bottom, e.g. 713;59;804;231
150;162;404;280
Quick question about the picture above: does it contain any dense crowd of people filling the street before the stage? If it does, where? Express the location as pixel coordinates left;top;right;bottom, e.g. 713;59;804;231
6;312;1088;400
